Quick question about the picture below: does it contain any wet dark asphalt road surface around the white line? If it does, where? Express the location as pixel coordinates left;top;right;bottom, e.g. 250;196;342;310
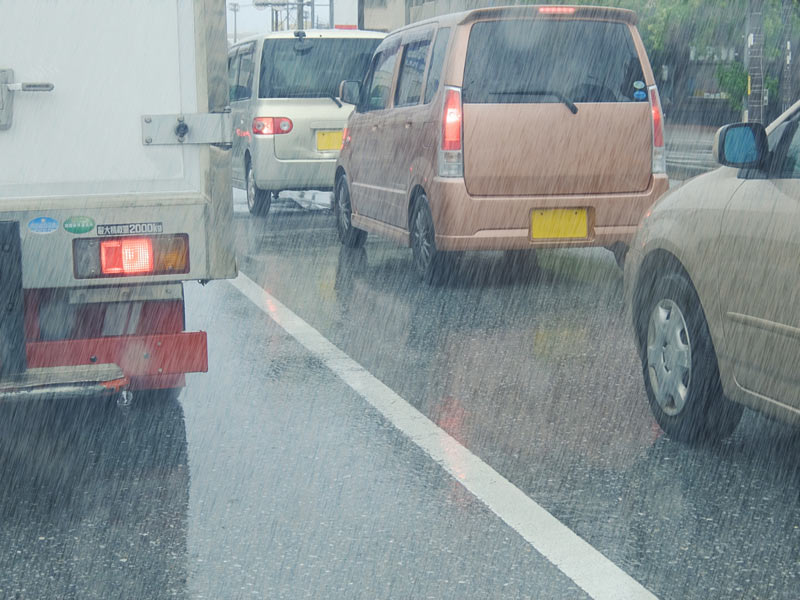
0;195;800;599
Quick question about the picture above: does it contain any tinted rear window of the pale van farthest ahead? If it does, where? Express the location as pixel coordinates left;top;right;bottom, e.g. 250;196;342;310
258;38;381;98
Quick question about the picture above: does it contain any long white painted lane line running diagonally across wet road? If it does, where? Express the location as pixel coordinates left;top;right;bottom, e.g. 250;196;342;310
230;273;656;600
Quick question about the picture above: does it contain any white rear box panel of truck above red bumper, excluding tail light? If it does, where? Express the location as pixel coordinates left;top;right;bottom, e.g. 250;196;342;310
0;0;236;289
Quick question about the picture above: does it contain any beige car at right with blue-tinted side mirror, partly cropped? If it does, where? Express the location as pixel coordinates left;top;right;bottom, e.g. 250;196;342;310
625;102;800;442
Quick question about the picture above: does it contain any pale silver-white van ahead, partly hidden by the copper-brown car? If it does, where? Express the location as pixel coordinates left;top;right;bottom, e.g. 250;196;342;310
228;29;385;216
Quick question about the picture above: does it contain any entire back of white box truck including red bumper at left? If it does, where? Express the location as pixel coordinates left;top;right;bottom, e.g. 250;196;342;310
0;0;236;404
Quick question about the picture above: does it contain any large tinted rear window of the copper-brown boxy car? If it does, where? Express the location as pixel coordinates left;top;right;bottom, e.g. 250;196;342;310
463;20;647;103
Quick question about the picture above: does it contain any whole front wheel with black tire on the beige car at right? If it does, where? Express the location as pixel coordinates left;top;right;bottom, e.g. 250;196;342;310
637;273;743;443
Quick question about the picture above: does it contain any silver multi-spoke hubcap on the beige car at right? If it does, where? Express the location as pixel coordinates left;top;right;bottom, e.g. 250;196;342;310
647;299;692;416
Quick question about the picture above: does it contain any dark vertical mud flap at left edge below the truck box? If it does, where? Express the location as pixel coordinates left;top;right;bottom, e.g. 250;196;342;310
0;221;27;380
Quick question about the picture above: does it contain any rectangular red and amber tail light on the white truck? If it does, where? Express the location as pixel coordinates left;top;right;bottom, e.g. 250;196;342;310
72;233;189;279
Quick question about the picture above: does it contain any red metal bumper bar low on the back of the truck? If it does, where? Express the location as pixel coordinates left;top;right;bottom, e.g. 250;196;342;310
26;331;208;378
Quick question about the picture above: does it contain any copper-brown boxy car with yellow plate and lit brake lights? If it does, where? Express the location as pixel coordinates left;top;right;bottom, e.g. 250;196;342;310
333;6;668;282
